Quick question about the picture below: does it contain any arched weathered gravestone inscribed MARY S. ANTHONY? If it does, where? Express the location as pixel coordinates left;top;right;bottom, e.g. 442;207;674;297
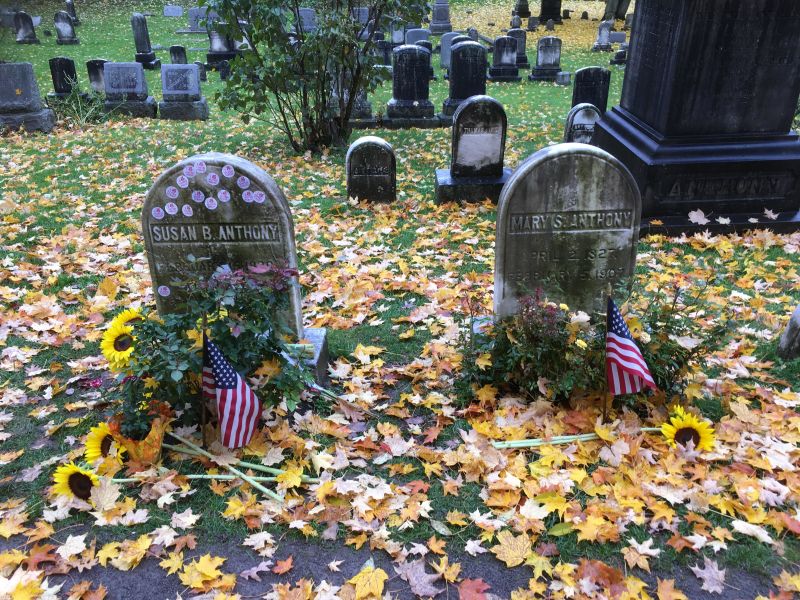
494;144;641;318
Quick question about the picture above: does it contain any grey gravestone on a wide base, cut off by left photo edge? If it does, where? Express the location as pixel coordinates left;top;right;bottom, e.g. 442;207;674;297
0;63;56;132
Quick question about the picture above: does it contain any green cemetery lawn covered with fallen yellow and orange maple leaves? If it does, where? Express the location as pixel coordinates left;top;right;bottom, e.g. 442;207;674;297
0;0;800;600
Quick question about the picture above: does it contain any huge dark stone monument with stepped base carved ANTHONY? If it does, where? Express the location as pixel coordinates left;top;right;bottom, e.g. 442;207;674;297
594;0;800;232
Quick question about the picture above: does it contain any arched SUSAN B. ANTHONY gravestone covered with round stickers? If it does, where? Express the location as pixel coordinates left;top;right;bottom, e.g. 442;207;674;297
142;152;303;339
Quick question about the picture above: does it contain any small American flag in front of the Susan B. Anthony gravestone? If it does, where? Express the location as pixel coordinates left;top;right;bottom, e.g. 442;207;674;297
203;334;261;448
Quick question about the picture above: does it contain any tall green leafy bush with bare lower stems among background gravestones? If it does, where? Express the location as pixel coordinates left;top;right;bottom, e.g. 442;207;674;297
201;0;427;152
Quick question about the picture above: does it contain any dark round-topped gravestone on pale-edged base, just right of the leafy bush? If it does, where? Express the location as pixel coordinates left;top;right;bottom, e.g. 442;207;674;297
386;44;434;120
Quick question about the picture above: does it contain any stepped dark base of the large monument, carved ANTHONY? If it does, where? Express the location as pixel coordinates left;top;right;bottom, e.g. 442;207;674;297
592;106;800;231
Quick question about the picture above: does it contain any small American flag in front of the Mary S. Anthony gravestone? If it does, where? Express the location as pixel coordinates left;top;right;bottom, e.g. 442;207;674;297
606;296;656;396
